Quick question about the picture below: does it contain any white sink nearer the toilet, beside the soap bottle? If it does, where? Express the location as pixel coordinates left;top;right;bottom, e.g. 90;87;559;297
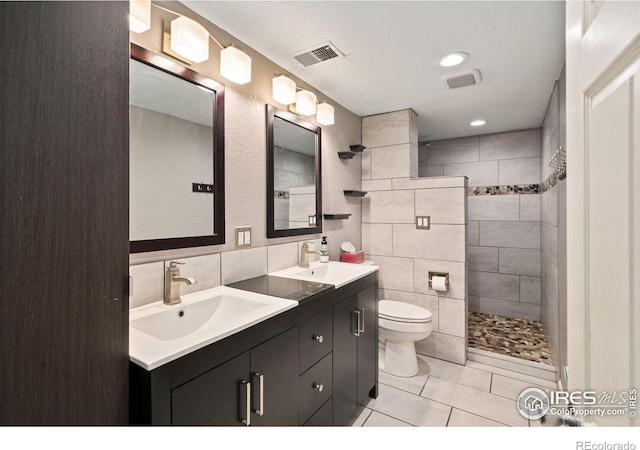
269;261;378;289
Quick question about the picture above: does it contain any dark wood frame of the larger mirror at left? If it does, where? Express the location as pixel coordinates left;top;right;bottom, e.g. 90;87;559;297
129;43;225;253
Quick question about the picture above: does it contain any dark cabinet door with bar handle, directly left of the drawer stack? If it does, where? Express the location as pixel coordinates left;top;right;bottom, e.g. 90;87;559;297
251;327;299;426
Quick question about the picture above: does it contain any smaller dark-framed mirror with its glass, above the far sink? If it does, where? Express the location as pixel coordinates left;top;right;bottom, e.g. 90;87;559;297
267;105;322;238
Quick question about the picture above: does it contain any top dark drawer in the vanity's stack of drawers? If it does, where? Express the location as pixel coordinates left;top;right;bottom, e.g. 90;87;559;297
300;308;333;373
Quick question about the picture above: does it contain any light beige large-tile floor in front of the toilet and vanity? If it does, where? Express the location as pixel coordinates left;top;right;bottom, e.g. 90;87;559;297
352;355;556;427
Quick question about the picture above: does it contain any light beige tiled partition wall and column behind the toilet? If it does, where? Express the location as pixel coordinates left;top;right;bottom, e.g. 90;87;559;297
362;110;468;364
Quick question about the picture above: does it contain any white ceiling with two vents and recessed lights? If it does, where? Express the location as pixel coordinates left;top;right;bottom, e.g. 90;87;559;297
184;0;564;141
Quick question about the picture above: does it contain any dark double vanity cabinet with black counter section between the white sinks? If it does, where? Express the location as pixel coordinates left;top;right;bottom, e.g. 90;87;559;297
130;263;378;426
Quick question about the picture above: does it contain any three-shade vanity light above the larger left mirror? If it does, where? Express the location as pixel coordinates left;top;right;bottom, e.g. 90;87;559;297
129;0;251;84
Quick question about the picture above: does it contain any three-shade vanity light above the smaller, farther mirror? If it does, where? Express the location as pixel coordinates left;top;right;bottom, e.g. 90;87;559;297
272;75;334;125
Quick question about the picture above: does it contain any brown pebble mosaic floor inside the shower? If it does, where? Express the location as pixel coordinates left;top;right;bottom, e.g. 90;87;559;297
469;312;551;364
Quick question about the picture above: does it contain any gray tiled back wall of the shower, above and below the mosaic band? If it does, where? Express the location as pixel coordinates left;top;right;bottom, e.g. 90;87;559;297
418;129;544;320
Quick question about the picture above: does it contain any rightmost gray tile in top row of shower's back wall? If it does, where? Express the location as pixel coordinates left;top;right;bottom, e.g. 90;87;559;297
479;128;541;161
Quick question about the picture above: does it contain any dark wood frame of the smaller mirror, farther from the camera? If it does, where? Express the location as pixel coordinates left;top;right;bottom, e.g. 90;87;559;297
267;105;322;238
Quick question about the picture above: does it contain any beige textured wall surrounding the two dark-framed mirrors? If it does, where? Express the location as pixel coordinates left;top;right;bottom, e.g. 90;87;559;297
130;2;361;296
